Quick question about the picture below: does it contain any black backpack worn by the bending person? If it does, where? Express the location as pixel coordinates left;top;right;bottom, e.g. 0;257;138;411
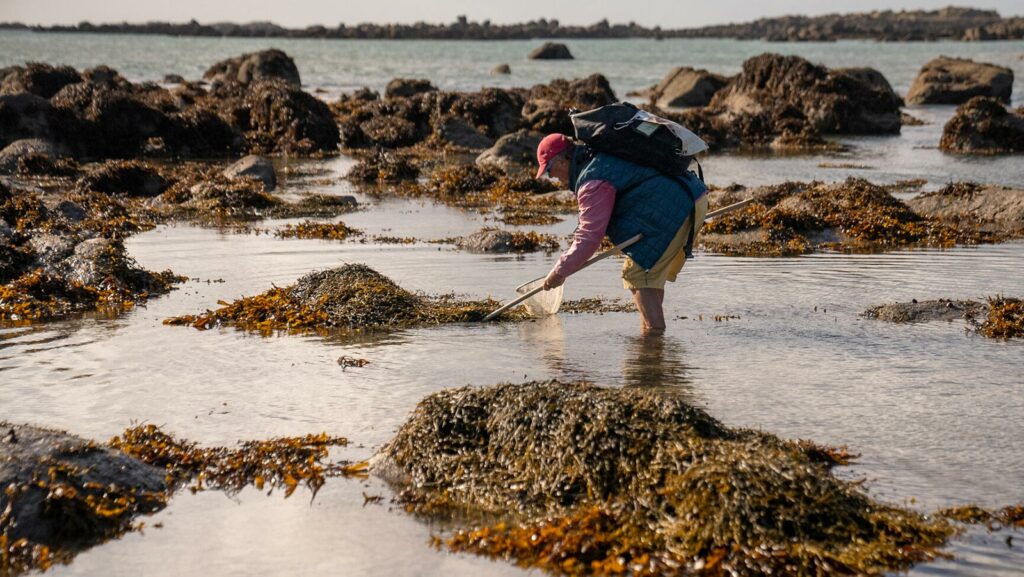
569;102;708;181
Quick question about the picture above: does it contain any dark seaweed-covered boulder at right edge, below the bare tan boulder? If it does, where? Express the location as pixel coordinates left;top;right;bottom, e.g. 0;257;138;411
939;96;1024;154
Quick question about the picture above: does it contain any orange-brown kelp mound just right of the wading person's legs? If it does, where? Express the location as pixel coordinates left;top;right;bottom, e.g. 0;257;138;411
701;178;1004;256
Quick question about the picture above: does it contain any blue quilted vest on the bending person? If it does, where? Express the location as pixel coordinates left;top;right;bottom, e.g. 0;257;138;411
569;147;708;270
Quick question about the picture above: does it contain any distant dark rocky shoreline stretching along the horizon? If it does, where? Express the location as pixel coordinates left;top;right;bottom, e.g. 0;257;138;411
0;6;1024;42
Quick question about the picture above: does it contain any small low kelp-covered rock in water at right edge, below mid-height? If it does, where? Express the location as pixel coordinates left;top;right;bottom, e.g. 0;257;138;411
864;295;1024;339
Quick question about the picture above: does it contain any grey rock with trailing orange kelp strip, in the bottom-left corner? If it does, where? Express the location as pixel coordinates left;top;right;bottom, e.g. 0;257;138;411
0;422;358;576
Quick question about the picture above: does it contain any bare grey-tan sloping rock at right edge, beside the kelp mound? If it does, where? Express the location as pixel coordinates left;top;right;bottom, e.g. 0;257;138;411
906;182;1024;236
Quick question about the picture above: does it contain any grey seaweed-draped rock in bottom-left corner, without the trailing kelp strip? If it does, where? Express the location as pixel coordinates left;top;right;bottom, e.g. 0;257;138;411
0;421;167;548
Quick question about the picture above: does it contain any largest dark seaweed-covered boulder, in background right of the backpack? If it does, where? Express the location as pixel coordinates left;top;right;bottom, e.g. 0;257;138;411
711;53;902;134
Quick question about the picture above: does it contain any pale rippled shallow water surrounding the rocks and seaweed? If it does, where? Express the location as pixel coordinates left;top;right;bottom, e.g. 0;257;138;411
0;32;1024;576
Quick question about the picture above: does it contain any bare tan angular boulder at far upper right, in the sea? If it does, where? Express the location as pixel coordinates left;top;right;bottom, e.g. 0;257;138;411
906;56;1014;105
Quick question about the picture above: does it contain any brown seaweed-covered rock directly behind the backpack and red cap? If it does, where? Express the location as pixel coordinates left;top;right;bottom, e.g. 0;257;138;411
522;74;617;134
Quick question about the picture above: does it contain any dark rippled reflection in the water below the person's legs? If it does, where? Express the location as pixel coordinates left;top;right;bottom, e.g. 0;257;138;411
623;333;693;397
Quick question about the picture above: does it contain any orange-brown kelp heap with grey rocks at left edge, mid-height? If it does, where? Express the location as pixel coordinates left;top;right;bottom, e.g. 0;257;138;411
0;178;180;323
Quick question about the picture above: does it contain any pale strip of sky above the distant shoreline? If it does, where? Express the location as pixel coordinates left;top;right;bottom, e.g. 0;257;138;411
0;0;1024;28
